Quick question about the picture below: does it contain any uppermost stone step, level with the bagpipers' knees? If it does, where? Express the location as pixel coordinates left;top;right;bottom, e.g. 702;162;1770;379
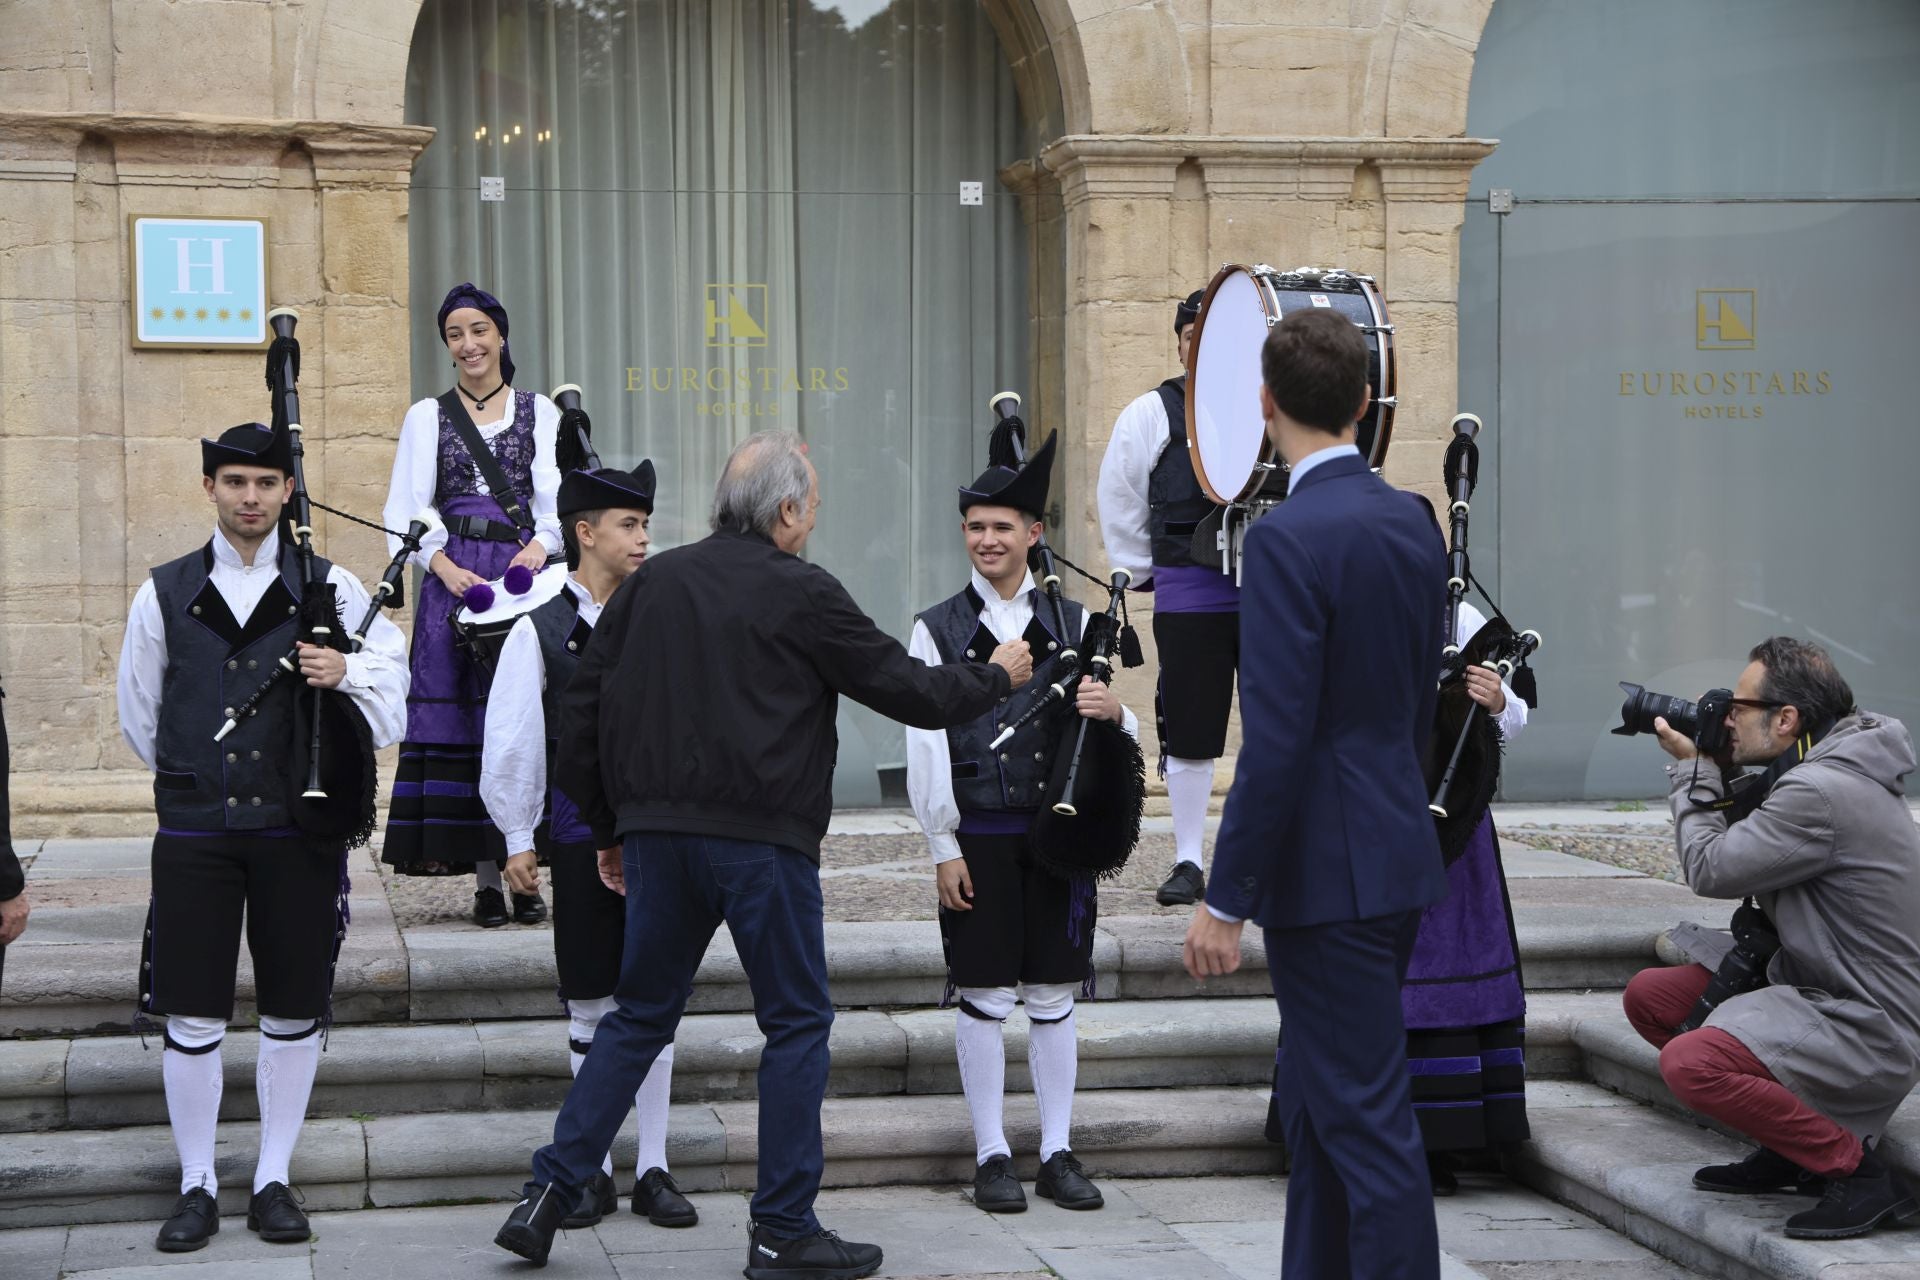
0;882;1724;1034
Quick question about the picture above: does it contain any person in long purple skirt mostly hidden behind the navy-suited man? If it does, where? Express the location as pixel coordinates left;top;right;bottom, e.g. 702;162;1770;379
1400;603;1528;1196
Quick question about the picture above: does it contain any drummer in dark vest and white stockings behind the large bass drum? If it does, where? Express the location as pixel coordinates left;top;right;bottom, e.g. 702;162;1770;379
1098;292;1240;906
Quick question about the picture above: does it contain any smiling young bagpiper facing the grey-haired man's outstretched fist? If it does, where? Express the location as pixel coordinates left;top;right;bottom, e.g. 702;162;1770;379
906;438;1139;1213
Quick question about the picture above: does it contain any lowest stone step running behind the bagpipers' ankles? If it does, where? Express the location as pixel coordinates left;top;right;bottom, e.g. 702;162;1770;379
0;1088;1283;1228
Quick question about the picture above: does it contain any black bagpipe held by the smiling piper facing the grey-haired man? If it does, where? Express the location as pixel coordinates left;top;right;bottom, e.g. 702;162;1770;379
987;391;1146;881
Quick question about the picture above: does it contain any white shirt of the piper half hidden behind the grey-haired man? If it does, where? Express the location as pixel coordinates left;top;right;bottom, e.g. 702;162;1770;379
480;578;605;854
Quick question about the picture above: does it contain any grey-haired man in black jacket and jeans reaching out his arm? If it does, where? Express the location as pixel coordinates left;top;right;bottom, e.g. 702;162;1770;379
493;432;1033;1280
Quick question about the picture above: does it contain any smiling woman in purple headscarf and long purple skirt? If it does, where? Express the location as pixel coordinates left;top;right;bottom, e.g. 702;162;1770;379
382;284;561;929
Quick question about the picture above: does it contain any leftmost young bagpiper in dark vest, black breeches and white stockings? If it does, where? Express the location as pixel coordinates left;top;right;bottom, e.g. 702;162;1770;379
119;424;407;1253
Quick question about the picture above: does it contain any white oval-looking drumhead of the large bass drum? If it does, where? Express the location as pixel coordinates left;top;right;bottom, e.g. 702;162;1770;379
1187;269;1267;503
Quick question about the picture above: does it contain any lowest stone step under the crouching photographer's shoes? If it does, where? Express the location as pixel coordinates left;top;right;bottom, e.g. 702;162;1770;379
1511;1082;1920;1280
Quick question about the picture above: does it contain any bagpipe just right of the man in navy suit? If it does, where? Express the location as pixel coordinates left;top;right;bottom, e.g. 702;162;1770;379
1427;413;1540;865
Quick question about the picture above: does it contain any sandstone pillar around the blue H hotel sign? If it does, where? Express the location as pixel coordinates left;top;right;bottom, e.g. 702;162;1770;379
0;111;432;835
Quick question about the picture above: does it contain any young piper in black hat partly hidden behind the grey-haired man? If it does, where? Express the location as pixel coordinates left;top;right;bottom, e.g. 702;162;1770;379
480;462;699;1228
